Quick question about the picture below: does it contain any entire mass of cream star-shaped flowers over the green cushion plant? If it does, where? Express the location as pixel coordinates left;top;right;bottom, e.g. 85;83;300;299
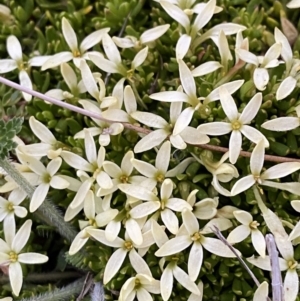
0;0;300;301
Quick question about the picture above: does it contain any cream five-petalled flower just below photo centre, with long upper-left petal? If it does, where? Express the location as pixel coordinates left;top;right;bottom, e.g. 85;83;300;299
119;179;192;234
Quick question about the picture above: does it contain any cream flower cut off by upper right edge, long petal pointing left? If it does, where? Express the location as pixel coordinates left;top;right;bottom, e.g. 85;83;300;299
261;105;300;132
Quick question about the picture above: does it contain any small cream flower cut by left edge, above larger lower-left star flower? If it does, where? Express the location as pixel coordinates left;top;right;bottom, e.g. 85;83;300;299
0;189;27;236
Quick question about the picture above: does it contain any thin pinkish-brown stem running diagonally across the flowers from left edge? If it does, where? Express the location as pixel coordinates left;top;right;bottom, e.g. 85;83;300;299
0;76;300;163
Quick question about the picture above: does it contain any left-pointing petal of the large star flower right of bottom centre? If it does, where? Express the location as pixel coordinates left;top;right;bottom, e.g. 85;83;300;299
155;235;193;257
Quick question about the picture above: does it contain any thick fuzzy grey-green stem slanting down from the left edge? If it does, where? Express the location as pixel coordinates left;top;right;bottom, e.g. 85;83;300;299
0;159;76;242
